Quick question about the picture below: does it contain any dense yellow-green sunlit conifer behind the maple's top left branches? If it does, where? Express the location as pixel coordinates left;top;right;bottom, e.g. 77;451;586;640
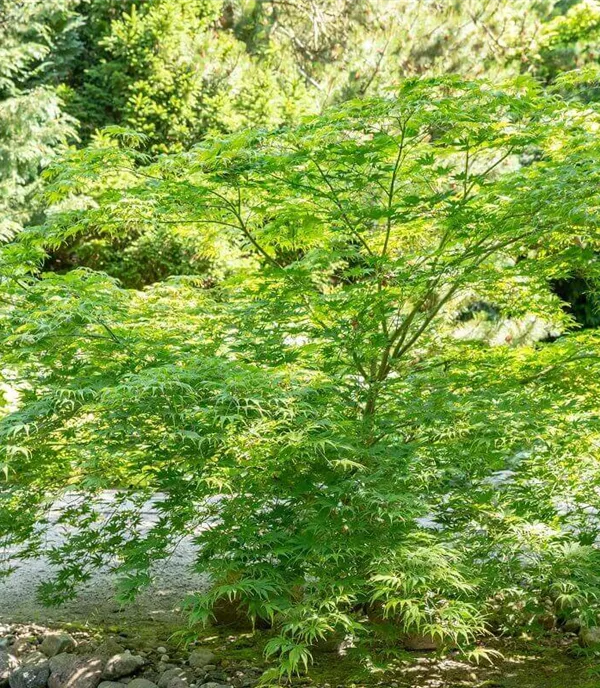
62;0;310;152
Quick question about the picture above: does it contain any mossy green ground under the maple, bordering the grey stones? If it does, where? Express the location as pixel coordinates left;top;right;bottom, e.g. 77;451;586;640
29;623;600;688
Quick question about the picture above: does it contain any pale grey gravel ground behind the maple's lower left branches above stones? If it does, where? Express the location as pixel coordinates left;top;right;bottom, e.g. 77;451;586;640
0;492;208;624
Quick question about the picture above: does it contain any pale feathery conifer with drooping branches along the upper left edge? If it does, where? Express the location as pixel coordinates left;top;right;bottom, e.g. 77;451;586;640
0;0;77;241
